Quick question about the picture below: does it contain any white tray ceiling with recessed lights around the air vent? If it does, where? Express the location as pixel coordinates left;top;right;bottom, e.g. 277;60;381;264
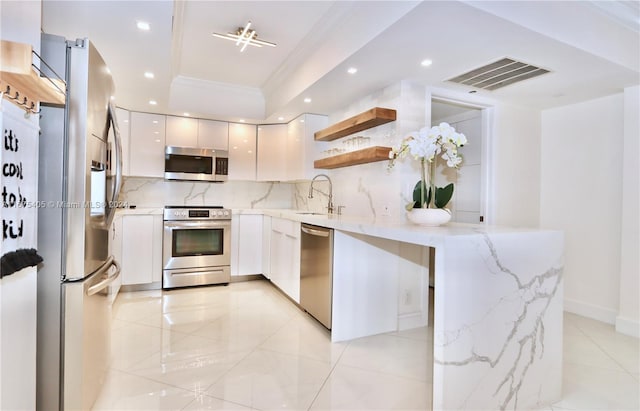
41;0;640;123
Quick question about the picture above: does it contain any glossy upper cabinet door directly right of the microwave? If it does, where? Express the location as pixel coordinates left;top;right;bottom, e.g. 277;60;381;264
229;123;256;181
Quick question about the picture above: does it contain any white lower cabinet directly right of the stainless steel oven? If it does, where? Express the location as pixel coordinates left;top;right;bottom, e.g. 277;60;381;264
231;215;262;276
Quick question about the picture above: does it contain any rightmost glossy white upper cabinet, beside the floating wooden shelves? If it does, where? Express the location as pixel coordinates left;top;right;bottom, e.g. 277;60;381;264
286;114;328;180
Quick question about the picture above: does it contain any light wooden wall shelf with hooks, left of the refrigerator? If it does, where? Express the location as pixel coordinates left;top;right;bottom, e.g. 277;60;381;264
0;40;66;105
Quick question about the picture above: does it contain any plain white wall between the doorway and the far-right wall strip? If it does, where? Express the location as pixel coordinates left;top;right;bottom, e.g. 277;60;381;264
540;94;624;324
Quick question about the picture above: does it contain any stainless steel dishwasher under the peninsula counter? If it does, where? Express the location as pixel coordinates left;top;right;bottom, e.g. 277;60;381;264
300;223;333;329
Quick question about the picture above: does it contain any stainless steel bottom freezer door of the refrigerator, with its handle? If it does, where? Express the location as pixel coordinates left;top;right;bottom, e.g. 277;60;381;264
61;256;120;410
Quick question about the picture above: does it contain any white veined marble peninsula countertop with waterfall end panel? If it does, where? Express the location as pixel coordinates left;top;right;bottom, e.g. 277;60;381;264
233;209;564;410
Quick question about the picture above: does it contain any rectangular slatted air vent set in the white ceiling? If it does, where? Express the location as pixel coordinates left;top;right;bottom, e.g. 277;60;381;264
448;57;549;90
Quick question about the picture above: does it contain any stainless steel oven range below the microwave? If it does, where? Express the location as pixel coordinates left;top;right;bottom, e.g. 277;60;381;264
162;206;231;289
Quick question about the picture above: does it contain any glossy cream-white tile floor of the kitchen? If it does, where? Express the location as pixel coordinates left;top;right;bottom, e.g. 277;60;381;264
94;281;640;410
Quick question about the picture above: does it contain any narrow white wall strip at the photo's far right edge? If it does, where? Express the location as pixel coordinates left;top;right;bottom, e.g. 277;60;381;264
616;86;640;337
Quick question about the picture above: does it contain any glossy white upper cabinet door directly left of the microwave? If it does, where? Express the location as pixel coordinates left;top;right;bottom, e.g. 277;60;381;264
129;112;165;177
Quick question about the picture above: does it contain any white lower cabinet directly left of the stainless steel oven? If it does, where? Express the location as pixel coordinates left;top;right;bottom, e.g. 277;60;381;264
112;214;162;286
